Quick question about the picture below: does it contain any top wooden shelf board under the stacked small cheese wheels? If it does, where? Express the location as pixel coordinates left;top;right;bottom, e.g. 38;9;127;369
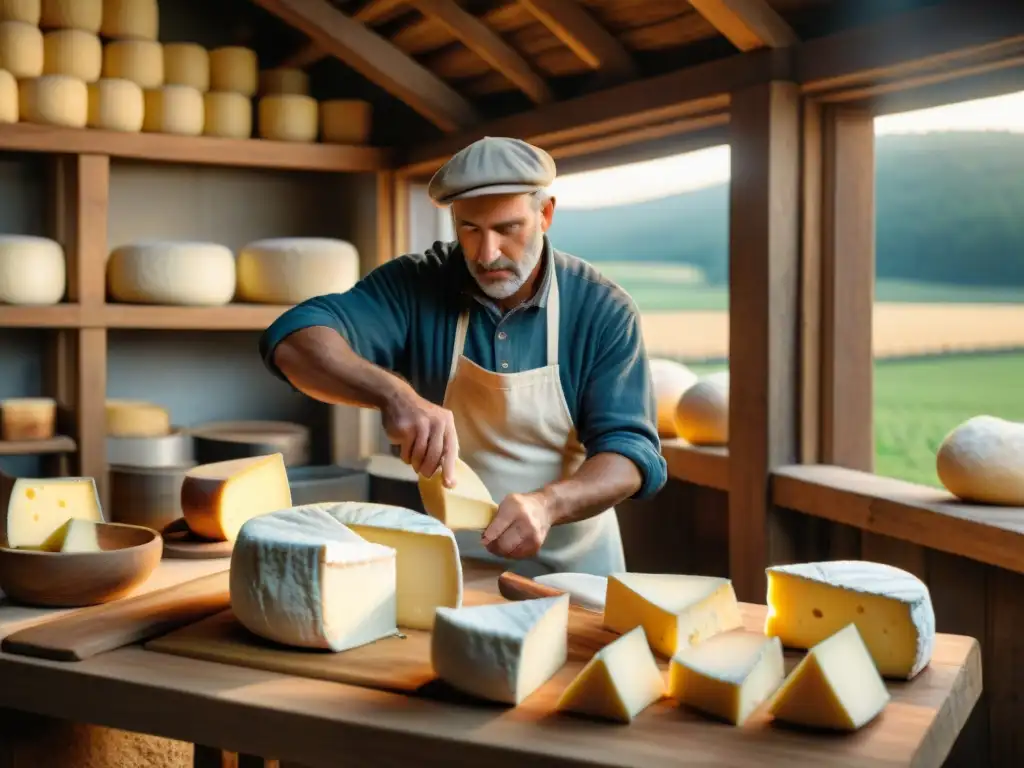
0;123;392;173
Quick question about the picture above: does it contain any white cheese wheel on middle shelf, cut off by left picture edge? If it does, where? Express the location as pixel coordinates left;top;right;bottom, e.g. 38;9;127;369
0;234;68;304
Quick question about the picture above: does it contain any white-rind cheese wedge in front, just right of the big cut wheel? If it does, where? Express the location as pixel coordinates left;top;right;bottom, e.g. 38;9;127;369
430;595;569;706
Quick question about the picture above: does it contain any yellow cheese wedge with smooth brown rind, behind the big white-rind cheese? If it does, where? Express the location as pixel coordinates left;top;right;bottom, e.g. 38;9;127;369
181;454;292;542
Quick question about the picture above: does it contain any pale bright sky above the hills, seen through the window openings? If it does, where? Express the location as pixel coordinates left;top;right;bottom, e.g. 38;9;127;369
552;91;1024;209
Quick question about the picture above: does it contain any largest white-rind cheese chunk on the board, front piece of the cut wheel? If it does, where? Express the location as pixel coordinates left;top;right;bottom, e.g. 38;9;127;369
229;507;397;651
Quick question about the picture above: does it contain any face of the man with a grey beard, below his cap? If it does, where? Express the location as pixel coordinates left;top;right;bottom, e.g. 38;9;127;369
452;195;555;300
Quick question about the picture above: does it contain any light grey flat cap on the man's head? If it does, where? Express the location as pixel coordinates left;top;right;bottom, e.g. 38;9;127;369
427;136;555;206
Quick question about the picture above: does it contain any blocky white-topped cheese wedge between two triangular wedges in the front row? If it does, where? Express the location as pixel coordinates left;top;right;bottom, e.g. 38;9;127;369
669;630;785;725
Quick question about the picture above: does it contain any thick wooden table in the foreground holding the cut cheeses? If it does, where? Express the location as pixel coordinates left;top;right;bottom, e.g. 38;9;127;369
0;566;981;768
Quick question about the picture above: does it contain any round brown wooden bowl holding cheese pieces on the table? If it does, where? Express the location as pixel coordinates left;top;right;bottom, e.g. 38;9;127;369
0;522;164;608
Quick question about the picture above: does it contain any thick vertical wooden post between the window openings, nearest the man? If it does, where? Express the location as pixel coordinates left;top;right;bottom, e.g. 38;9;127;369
729;82;801;600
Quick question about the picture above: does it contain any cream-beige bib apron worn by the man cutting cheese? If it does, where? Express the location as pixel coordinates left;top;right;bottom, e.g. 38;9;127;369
444;264;626;577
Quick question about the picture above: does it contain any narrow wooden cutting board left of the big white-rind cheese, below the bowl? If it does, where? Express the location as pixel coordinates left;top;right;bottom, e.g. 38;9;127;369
0;570;230;662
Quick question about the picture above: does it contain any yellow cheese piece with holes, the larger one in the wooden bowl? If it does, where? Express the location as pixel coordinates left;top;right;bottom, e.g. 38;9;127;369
4;477;103;549
